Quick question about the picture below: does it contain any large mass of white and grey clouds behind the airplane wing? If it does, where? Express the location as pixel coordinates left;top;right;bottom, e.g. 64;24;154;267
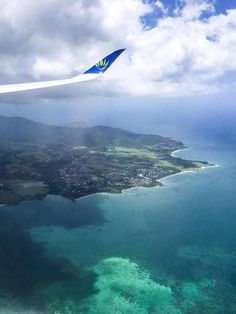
0;0;236;102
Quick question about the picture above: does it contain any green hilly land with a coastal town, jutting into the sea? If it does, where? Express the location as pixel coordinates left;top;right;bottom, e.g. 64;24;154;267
0;117;210;204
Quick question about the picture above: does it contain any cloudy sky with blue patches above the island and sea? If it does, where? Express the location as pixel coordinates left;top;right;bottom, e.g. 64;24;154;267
0;0;236;129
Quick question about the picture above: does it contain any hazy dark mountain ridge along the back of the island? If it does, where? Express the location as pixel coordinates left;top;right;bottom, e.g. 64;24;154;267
0;116;181;147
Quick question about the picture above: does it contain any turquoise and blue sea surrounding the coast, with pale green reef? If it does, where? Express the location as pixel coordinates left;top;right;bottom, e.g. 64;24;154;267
0;138;236;314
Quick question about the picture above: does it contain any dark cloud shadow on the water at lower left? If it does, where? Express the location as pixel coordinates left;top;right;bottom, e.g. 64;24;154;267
0;196;105;311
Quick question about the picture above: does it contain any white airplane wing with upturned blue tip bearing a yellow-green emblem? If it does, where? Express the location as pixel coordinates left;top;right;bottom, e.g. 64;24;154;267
0;49;125;94
